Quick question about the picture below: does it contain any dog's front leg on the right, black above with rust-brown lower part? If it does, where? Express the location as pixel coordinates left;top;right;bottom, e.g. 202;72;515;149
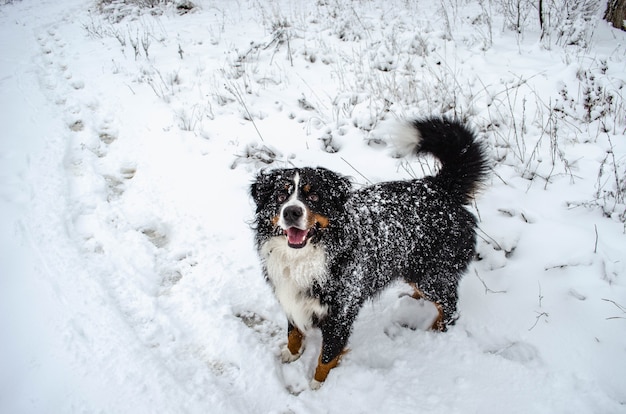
310;317;352;390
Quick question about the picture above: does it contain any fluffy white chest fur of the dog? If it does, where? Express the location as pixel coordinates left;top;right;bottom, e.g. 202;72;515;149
261;237;328;331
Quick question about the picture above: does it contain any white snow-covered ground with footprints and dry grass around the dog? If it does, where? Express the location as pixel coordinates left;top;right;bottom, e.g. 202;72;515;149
0;0;626;413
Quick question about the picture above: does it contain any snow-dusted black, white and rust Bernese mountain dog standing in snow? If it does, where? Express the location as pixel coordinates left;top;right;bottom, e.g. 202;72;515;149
250;117;489;389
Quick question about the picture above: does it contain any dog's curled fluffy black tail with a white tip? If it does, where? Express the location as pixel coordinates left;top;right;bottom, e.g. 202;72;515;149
394;118;489;203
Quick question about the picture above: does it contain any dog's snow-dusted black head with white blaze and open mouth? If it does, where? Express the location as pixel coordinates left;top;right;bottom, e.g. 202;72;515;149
250;168;351;249
